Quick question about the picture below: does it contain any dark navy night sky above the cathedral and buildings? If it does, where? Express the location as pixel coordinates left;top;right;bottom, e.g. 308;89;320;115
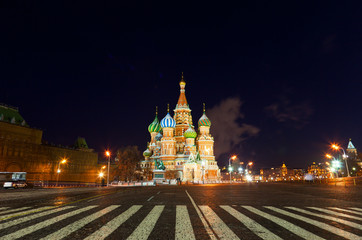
0;1;362;167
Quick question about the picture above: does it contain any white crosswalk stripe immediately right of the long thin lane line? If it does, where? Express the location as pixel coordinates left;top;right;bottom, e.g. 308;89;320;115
199;205;239;239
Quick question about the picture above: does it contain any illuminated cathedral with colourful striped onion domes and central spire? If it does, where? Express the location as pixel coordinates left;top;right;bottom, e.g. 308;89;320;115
140;75;220;182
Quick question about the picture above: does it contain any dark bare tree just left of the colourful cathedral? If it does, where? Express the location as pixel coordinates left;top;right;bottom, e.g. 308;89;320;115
114;146;142;181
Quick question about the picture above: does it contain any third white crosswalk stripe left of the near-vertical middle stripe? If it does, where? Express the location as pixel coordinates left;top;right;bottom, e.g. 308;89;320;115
42;205;120;240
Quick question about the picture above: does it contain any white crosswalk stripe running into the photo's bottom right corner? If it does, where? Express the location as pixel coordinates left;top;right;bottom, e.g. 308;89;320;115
265;207;361;240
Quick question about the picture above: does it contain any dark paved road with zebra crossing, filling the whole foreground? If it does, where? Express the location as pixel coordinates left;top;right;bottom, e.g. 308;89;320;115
0;184;362;240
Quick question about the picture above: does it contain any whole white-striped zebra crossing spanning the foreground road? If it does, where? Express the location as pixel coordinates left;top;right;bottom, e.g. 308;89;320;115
0;205;362;240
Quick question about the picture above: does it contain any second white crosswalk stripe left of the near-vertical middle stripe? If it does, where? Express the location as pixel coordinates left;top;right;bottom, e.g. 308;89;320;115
86;205;142;240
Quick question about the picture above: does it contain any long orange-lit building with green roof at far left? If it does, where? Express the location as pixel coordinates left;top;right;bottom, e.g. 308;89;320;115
0;105;99;183
